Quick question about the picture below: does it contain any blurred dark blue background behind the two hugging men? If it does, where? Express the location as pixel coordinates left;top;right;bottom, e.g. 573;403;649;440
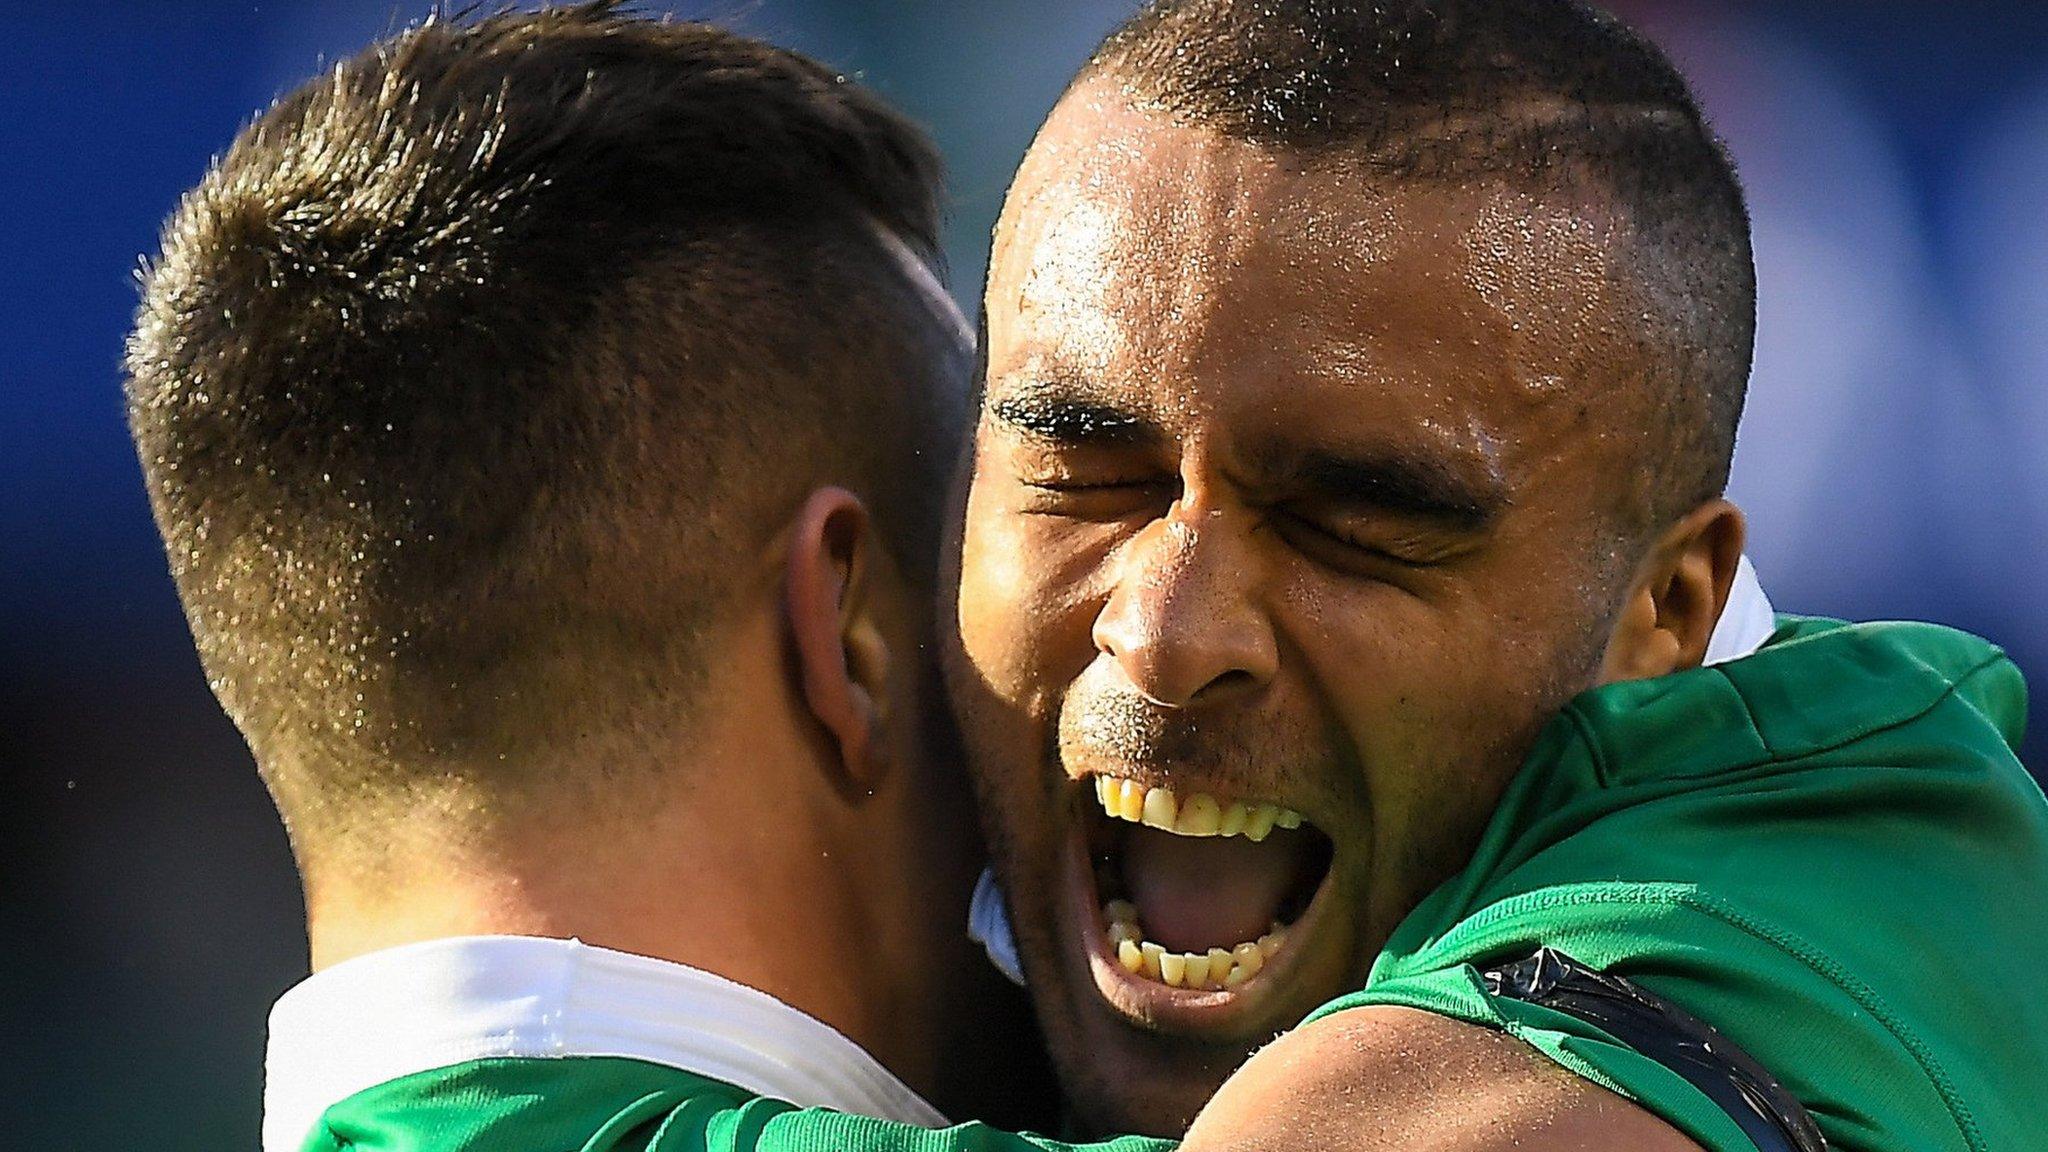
0;0;2048;1150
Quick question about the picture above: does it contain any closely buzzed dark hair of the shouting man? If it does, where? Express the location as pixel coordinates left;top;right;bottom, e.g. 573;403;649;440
1075;0;1757;527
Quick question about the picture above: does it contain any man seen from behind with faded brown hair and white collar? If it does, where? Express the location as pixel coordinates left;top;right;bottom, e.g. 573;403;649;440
129;4;1138;1152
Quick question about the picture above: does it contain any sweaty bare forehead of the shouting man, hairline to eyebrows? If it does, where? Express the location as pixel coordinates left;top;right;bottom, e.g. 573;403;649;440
987;107;1703;531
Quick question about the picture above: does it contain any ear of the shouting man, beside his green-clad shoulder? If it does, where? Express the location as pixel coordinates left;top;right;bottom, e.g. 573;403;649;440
1599;498;1749;685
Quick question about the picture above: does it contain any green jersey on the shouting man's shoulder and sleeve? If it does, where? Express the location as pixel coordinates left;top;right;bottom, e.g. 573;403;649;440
1317;617;2048;1152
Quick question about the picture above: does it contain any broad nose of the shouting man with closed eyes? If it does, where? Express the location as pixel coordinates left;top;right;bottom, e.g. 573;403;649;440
1094;504;1280;707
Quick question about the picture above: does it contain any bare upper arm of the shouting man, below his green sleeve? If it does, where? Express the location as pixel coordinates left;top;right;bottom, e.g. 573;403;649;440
1182;1006;1700;1152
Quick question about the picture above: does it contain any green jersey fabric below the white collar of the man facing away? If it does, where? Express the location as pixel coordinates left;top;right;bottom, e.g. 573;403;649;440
301;1056;1174;1152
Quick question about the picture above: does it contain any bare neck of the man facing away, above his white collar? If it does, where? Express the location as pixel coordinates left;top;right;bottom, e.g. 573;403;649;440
305;668;965;1097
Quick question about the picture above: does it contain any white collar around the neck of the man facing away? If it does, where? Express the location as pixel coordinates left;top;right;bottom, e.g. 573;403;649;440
262;937;946;1152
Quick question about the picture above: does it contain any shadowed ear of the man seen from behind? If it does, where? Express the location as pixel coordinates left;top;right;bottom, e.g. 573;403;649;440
782;488;889;789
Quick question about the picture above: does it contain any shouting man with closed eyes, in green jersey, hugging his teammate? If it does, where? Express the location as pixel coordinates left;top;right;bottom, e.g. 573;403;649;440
948;0;2048;1152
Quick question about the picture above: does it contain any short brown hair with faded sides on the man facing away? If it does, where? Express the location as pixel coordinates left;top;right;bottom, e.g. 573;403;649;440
127;2;971;859
